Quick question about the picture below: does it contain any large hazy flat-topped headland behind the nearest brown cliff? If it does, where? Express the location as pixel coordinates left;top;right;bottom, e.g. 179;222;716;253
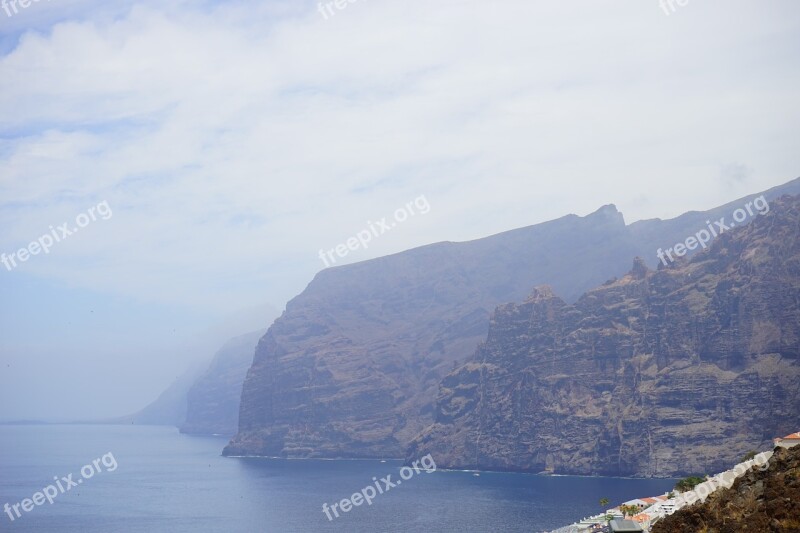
224;180;800;457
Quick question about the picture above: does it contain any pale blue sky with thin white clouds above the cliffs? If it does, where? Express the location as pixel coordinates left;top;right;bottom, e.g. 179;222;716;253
0;0;800;420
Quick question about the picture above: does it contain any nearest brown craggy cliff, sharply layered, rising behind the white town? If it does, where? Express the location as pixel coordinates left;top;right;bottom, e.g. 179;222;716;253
408;197;800;476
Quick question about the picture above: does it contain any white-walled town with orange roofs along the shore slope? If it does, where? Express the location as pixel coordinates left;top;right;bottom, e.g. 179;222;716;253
550;431;800;533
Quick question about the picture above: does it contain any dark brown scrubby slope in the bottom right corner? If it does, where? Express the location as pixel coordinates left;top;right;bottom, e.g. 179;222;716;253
652;446;800;533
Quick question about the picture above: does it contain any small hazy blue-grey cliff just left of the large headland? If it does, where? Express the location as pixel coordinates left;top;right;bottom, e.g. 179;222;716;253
179;330;265;437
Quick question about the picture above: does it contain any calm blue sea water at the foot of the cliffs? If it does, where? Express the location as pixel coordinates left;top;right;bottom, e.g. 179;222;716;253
0;425;675;533
